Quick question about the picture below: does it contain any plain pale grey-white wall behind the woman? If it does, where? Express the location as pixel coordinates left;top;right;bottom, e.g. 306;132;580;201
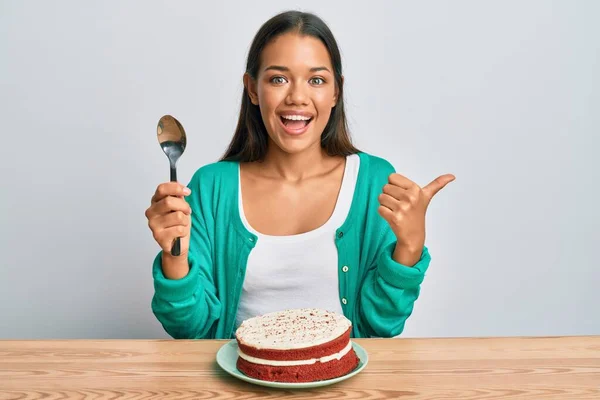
0;0;600;338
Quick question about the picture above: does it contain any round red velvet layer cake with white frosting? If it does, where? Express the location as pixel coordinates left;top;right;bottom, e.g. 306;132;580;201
235;308;359;382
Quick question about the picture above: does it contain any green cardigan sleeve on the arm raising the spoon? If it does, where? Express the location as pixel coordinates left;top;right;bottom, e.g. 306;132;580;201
151;170;221;339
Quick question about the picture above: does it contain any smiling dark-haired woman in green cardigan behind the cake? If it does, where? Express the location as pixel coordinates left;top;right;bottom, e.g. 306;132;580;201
146;11;454;339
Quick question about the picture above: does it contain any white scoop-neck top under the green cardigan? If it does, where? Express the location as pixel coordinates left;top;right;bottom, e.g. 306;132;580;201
236;154;360;328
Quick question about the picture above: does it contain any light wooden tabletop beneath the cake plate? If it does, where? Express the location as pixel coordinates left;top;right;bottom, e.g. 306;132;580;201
0;336;600;400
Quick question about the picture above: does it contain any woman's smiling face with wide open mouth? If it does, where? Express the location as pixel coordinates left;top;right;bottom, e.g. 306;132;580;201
244;33;337;154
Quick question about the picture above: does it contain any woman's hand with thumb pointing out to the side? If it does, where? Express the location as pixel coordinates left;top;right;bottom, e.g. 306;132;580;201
378;173;455;266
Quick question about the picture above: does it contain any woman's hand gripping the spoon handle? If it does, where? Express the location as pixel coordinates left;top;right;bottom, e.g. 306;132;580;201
146;182;192;260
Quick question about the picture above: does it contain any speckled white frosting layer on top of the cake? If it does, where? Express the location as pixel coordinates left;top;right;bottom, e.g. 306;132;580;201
235;308;352;350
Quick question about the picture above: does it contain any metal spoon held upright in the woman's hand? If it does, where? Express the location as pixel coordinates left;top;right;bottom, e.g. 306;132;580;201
156;115;186;256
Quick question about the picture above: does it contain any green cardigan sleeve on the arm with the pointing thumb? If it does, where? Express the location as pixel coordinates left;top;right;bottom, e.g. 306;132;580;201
358;156;431;337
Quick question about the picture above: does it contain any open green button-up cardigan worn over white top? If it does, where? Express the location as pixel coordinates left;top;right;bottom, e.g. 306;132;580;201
151;152;431;339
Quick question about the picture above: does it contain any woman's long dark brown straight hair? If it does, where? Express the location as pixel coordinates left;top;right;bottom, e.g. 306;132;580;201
222;11;359;162
